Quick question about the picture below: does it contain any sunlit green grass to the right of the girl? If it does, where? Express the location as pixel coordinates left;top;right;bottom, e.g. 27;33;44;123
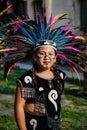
62;84;87;130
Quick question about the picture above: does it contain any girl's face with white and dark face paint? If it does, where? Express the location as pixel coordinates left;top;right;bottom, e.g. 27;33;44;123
34;46;56;70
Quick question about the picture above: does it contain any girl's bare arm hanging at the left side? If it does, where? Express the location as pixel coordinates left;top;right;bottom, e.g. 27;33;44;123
15;84;27;130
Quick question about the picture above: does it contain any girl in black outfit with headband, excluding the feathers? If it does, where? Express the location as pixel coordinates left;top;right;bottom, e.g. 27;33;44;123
15;40;65;130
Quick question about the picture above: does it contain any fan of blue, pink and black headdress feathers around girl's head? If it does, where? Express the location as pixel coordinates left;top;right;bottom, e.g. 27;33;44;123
0;14;87;77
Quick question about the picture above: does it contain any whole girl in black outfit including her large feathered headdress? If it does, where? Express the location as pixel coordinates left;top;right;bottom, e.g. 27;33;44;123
0;11;87;130
